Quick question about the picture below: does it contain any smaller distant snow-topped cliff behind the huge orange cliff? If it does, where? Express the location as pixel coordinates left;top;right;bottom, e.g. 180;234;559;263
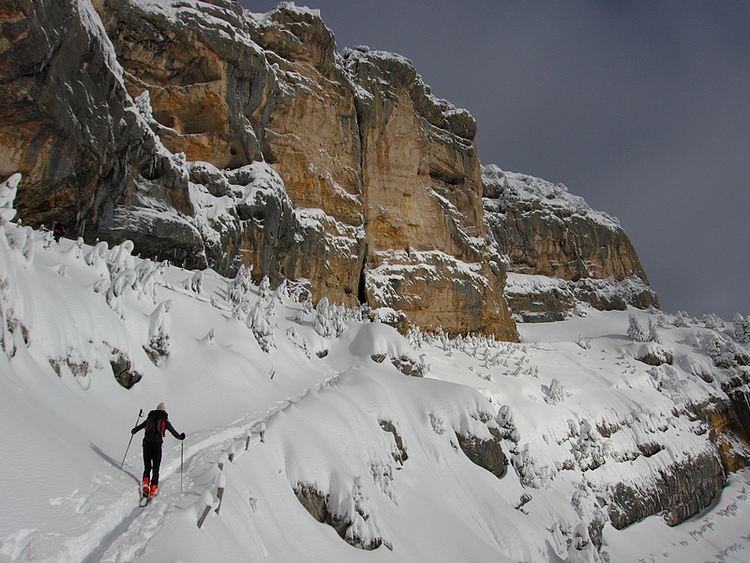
482;165;659;322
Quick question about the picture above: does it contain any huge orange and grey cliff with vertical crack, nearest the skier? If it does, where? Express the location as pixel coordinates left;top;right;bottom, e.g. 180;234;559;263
0;0;516;339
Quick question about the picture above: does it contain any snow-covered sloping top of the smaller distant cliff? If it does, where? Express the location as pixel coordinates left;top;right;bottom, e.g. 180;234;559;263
482;164;620;229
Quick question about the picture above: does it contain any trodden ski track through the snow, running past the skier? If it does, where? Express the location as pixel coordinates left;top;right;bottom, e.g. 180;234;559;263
80;372;346;563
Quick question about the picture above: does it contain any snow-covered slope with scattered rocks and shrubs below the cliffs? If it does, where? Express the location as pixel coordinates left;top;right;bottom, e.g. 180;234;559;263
0;177;750;562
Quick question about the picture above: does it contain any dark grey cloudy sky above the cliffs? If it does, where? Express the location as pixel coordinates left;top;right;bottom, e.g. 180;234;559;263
247;0;750;318
